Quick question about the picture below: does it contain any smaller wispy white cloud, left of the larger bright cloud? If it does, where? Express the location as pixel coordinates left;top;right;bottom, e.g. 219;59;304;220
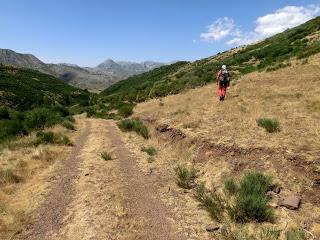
200;17;235;42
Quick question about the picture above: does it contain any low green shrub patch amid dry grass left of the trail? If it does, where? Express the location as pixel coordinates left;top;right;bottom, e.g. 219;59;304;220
33;131;72;146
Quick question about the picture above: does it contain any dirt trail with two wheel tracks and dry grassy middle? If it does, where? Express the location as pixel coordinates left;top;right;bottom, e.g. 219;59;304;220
17;119;186;240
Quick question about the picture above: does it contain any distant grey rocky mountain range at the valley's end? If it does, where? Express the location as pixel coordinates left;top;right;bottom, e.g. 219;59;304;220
0;49;164;92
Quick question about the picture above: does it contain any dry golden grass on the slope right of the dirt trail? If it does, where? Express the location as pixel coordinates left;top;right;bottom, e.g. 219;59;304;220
127;54;320;239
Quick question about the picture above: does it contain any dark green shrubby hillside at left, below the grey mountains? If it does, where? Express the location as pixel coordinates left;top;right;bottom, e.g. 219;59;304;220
0;65;87;111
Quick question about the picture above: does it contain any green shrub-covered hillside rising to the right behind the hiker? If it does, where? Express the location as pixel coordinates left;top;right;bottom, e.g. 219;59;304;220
101;17;320;102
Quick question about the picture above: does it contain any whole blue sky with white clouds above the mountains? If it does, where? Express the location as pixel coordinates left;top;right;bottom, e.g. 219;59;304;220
0;0;320;67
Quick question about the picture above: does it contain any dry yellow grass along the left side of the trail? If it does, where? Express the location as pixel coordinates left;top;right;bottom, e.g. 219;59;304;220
0;117;81;239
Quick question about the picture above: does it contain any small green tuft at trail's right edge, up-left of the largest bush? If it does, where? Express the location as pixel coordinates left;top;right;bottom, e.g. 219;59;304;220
174;165;197;189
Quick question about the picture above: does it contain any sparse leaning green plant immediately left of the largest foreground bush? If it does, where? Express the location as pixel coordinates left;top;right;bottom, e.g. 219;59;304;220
195;182;226;222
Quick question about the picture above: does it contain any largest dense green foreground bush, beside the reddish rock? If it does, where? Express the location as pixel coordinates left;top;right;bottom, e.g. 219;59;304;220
228;172;274;222
